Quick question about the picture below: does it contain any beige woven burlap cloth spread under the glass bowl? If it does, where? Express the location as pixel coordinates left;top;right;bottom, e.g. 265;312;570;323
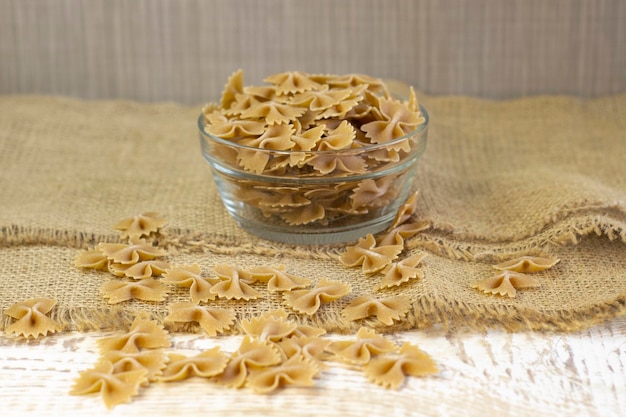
0;92;626;332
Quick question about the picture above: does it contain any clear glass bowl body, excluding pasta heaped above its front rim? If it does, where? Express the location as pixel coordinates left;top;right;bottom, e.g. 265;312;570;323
198;105;428;244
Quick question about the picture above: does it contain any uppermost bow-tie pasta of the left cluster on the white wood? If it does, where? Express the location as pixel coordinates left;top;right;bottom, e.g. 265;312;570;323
97;316;170;355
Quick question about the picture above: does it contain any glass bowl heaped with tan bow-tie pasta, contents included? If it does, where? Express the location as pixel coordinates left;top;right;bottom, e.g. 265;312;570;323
198;71;428;244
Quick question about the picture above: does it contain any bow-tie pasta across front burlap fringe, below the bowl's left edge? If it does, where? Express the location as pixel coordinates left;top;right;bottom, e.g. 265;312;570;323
164;303;236;336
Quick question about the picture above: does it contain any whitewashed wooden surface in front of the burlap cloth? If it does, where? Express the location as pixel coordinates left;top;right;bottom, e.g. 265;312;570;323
0;317;626;417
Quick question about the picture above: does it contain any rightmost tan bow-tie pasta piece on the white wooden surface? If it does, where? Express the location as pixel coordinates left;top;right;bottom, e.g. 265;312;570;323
363;342;439;389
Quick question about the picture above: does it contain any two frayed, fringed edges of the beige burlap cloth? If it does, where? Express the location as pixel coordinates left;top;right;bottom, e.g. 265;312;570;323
0;212;626;333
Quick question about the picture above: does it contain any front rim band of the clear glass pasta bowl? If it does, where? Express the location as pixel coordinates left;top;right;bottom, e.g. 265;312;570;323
198;104;429;155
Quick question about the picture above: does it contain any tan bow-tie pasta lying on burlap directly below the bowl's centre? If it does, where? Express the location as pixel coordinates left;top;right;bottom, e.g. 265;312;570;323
283;278;352;316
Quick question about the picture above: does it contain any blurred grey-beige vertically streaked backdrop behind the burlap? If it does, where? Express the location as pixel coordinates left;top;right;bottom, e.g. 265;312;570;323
0;0;626;104
